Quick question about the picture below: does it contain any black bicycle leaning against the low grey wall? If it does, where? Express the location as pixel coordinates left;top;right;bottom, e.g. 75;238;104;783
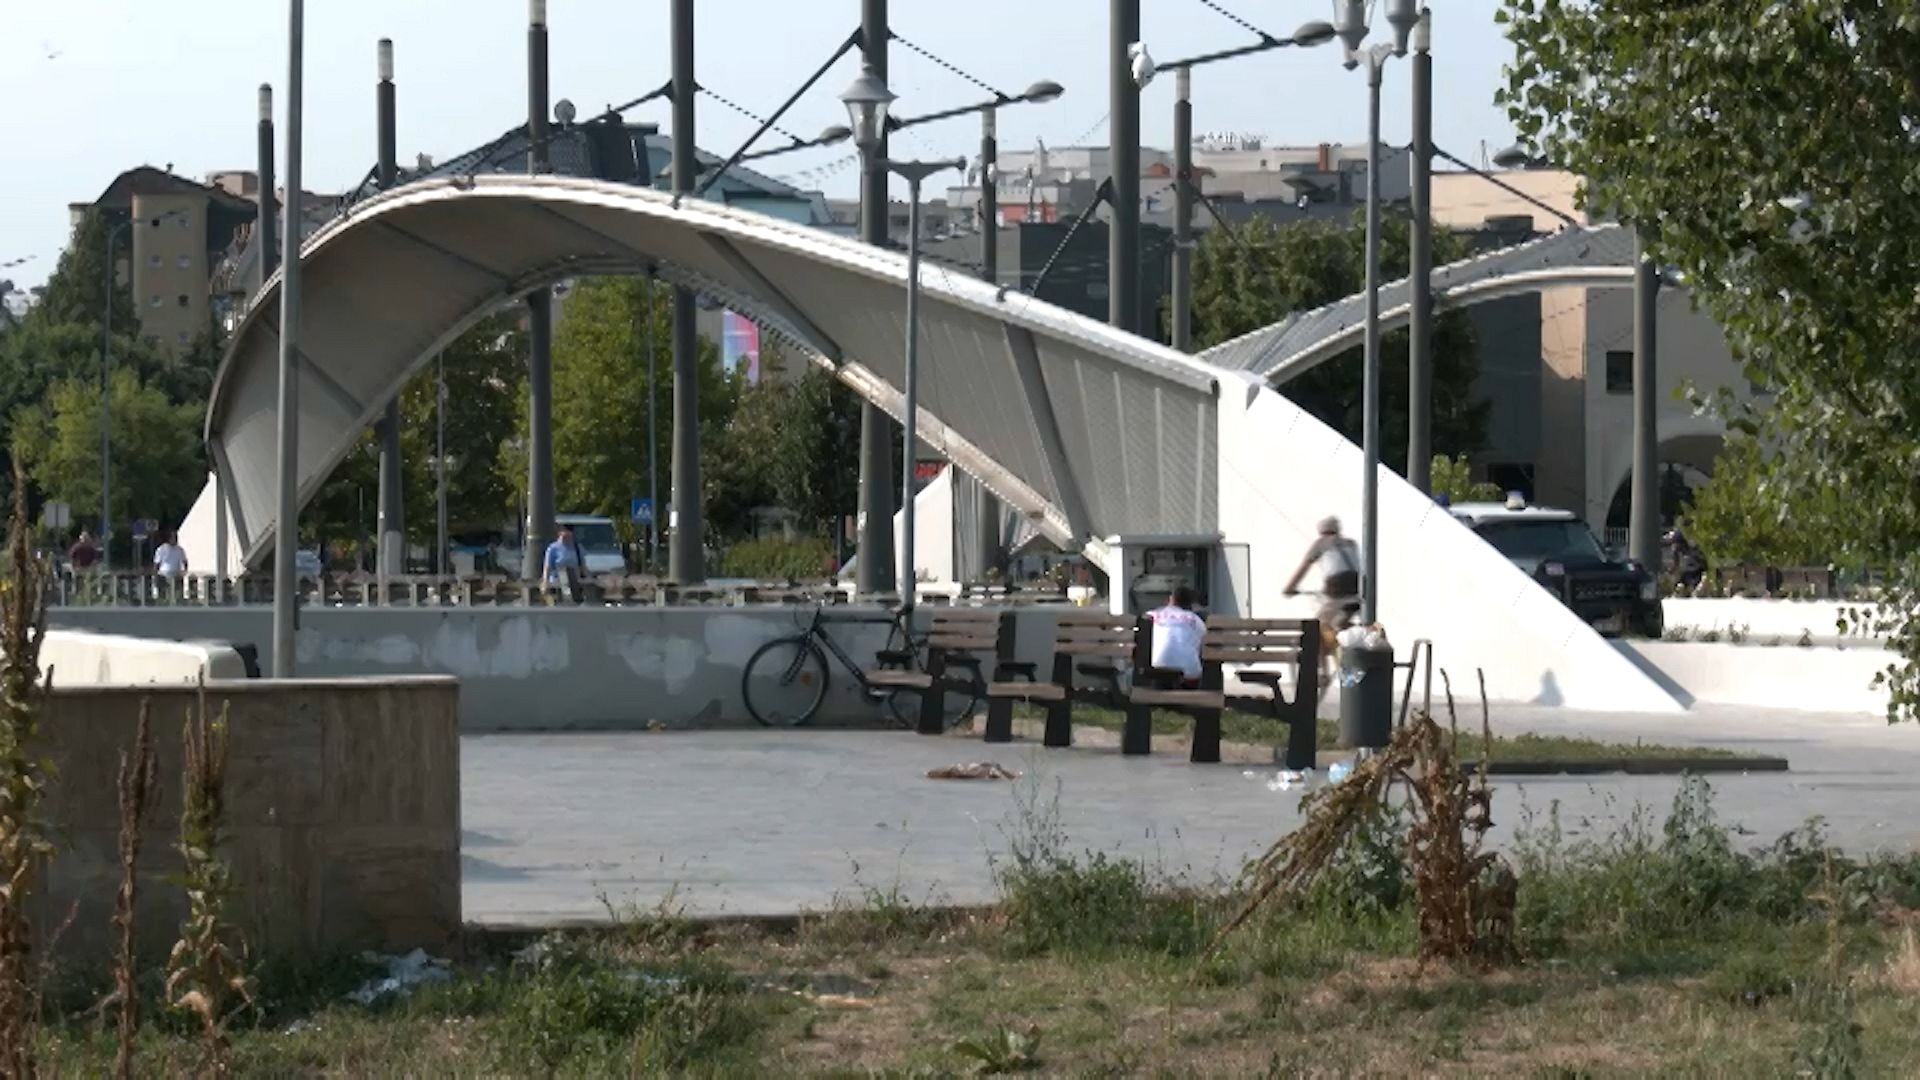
739;605;985;728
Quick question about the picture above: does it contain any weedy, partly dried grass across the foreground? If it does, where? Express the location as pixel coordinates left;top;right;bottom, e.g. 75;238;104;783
40;782;1920;1076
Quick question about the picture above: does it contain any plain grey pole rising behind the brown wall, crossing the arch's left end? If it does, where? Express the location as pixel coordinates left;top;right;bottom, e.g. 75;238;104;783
273;0;307;678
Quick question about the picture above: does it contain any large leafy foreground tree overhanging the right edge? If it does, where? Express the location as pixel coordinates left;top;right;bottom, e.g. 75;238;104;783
1500;0;1920;719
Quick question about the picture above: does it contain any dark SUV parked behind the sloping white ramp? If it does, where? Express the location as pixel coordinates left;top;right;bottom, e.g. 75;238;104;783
1452;498;1667;638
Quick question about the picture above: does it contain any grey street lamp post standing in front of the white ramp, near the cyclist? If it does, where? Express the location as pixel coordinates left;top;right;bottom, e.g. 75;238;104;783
1334;0;1419;623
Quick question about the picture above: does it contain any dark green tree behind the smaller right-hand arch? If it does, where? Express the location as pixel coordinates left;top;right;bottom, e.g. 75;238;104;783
1194;217;1488;469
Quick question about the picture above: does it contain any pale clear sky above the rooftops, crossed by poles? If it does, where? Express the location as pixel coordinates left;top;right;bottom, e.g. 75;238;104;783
0;0;1513;288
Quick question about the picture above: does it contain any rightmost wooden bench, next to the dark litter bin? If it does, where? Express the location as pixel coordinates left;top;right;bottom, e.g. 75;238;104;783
1119;615;1321;769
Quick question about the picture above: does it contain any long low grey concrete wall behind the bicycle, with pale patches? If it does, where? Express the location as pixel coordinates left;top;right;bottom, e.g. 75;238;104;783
50;607;1052;732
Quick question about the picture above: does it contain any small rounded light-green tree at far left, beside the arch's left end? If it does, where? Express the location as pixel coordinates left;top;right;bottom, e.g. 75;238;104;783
13;369;207;525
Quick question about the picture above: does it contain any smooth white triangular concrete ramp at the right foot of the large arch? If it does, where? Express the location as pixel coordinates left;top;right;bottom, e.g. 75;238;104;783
1219;377;1684;713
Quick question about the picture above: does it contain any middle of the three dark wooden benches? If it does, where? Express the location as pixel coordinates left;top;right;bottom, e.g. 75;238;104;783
987;609;1150;748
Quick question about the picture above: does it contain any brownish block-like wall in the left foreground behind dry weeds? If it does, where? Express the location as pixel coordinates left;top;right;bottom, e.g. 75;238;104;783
33;678;461;967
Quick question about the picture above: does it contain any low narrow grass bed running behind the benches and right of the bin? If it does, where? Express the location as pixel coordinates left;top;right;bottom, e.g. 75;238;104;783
1016;705;1755;765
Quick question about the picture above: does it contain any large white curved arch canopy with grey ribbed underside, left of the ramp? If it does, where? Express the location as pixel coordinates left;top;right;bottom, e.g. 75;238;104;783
207;177;1215;563
